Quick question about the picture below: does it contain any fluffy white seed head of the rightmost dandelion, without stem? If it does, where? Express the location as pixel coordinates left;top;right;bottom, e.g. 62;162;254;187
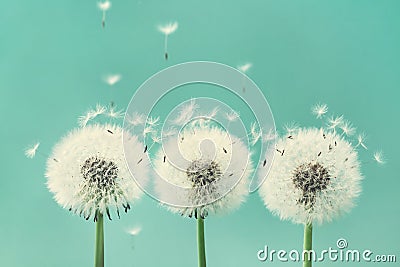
259;128;363;225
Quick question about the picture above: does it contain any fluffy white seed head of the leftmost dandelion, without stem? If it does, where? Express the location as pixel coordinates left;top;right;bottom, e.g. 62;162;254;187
46;124;148;221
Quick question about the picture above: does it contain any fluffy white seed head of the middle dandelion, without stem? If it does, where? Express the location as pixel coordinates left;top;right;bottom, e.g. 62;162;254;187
154;127;253;219
